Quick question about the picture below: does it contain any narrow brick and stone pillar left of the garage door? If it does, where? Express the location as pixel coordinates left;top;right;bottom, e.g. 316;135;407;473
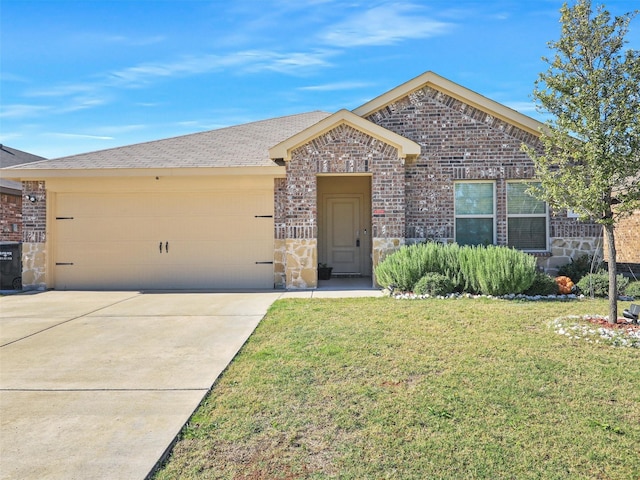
22;181;47;290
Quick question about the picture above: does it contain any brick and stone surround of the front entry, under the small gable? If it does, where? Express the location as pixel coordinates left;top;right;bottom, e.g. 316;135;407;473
282;124;405;288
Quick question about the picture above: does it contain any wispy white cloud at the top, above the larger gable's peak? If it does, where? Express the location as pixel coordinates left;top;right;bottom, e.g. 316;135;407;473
321;3;454;47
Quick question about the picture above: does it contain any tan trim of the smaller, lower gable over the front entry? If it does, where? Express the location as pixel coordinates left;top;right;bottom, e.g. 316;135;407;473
269;109;420;161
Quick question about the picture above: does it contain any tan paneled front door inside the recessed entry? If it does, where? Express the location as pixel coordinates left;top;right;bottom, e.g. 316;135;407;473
324;195;363;274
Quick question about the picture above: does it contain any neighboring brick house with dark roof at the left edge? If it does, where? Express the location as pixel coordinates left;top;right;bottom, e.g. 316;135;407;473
0;144;44;242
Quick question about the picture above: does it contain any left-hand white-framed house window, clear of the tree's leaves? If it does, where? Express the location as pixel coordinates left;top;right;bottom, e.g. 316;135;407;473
454;182;496;245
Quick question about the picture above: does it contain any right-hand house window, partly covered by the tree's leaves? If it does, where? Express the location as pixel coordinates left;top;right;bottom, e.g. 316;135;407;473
507;182;549;250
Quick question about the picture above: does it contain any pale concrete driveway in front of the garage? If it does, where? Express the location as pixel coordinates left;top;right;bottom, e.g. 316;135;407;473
0;291;282;480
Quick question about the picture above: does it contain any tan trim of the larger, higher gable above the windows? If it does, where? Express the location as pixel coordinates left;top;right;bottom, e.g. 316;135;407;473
353;72;544;136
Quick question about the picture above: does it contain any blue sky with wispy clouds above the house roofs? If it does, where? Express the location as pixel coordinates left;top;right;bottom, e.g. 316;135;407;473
0;0;640;158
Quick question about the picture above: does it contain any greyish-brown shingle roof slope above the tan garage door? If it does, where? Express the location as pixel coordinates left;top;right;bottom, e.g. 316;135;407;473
6;111;330;170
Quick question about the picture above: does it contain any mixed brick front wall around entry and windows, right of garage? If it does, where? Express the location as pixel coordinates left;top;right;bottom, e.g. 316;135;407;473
275;86;602;287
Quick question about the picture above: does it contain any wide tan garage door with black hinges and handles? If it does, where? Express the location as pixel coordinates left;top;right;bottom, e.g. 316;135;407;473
54;191;273;289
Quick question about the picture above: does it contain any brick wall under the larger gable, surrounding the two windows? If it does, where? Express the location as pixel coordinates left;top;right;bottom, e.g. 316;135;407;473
367;81;601;265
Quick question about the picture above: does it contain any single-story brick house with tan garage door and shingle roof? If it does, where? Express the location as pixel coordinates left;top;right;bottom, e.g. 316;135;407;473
6;72;602;289
